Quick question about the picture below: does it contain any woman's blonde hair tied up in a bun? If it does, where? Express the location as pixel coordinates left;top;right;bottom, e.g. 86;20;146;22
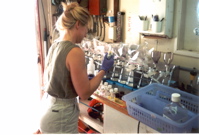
55;2;91;31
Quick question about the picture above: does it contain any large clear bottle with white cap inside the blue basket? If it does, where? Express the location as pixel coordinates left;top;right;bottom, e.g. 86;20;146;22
163;93;188;123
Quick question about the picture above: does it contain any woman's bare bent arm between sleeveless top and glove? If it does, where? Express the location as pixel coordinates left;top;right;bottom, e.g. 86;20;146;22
66;48;105;99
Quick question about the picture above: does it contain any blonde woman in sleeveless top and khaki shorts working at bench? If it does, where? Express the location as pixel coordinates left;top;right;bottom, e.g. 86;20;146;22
40;2;114;134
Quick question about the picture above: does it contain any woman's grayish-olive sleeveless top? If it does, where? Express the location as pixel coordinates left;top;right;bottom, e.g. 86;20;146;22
44;41;79;99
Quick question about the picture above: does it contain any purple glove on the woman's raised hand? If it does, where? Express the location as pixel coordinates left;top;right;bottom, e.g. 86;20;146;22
101;53;114;72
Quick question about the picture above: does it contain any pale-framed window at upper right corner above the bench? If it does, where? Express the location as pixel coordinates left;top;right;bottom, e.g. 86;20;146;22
175;0;199;57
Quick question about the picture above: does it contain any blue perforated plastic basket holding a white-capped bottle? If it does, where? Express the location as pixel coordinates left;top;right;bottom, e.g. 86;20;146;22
122;83;199;133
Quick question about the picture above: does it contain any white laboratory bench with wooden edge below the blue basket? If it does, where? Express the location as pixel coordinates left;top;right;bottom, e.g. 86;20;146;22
79;83;199;134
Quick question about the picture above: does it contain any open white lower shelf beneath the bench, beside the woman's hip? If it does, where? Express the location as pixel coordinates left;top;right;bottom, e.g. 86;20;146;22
79;100;104;133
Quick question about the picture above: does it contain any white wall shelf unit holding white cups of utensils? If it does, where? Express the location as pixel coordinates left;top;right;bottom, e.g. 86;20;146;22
139;0;174;38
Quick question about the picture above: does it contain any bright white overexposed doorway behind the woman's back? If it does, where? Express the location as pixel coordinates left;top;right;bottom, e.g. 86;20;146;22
0;0;40;134
